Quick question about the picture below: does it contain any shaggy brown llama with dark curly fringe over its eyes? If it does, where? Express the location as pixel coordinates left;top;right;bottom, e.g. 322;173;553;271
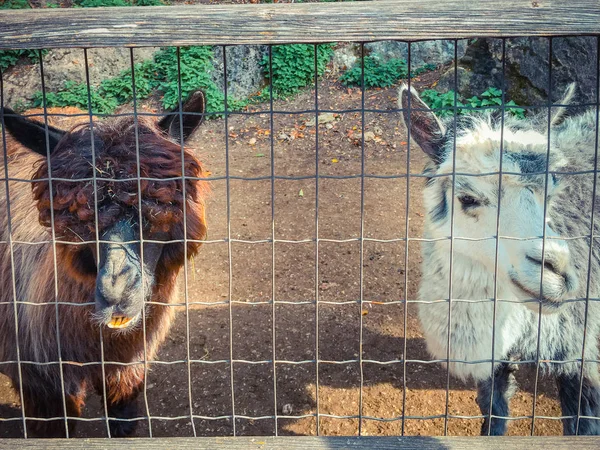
0;92;207;437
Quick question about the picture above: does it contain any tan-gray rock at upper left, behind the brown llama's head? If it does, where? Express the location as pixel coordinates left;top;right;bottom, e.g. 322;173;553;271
3;48;157;106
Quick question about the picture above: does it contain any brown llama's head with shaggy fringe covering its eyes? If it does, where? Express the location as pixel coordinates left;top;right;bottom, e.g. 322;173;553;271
4;92;207;331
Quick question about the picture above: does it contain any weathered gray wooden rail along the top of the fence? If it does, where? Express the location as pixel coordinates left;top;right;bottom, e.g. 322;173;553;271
0;0;600;49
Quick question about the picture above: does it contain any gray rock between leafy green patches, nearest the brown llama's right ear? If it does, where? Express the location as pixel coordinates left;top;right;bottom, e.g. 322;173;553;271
211;45;269;100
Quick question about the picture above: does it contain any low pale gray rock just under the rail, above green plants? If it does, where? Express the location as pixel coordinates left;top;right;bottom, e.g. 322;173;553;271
365;40;467;68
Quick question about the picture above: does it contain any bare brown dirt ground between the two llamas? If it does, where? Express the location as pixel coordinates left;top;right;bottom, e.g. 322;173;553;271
0;73;562;437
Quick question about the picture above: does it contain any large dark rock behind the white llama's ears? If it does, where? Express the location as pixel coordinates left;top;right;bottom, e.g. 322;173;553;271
436;36;598;106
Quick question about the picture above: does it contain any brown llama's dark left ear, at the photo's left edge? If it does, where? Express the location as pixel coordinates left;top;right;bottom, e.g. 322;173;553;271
0;107;66;156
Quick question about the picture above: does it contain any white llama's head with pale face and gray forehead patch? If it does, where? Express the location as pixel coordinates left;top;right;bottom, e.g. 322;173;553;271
399;86;578;311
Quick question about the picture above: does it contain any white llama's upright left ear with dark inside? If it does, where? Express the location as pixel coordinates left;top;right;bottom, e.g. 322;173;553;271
398;85;446;164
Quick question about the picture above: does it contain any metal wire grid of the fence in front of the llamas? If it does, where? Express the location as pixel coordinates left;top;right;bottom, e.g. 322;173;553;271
0;37;600;437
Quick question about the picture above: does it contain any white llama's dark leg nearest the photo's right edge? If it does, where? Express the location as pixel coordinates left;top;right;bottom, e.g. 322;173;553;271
557;374;600;435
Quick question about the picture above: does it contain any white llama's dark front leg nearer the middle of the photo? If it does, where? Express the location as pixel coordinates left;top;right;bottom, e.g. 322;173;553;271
477;363;516;436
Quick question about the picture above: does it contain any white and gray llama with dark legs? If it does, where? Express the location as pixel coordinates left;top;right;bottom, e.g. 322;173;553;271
399;85;600;435
